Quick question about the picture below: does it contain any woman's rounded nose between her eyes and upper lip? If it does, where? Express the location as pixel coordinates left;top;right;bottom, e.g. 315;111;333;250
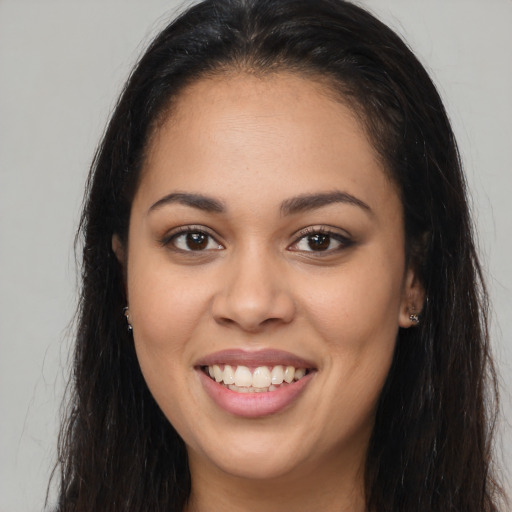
212;248;295;332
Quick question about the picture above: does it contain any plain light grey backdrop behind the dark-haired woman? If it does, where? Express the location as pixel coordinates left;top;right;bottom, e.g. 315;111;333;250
0;0;512;512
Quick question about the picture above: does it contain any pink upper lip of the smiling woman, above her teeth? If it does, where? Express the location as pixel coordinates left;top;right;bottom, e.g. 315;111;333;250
195;349;315;369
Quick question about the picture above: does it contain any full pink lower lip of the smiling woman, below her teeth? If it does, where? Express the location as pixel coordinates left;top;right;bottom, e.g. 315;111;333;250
197;369;315;418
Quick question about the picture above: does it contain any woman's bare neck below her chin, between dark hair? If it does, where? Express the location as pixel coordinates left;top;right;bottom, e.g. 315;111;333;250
185;456;365;512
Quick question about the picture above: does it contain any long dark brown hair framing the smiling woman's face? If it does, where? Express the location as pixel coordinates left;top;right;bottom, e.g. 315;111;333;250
51;0;500;512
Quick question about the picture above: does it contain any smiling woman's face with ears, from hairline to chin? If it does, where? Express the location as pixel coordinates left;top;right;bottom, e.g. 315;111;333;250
118;73;421;484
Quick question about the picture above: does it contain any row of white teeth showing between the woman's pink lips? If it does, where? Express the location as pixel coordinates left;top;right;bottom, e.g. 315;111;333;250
201;364;312;393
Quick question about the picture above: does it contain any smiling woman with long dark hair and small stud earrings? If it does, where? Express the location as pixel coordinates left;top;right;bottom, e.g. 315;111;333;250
53;0;499;512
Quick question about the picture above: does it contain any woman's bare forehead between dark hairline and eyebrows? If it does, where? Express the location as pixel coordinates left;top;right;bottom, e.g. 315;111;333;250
137;73;400;215
